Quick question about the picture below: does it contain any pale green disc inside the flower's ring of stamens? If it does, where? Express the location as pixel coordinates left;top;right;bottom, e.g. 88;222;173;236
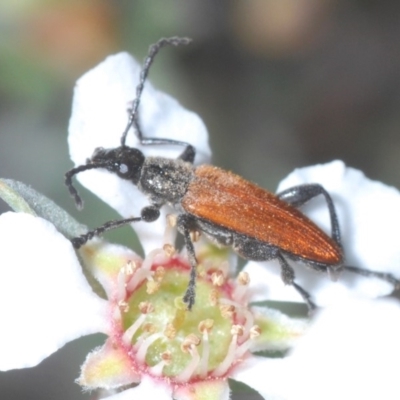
122;269;232;377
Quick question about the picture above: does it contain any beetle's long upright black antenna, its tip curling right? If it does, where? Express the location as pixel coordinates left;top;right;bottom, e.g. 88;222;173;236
121;36;192;146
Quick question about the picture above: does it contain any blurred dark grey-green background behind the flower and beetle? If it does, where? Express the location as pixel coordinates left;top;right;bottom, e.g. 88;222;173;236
0;0;400;400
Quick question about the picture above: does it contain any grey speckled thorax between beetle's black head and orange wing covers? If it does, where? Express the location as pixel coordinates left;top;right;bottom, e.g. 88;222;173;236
138;157;194;205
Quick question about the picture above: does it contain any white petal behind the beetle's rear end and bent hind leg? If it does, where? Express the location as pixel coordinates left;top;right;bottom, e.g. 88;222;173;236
246;161;400;305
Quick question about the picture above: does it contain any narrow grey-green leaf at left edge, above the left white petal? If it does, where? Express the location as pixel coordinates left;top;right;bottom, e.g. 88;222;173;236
0;179;87;239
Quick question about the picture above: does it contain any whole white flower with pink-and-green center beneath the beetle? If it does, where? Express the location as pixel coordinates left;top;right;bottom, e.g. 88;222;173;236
0;47;400;400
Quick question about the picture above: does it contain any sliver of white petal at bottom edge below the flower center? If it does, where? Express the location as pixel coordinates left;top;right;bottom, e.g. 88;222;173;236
106;376;172;400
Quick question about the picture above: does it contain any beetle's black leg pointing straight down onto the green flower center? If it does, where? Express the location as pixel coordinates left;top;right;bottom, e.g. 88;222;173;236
177;214;197;310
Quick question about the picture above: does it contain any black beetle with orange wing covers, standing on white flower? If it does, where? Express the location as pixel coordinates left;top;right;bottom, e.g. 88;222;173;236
65;37;400;311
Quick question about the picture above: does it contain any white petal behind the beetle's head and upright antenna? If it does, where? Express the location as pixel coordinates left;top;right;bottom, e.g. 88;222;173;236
68;53;210;252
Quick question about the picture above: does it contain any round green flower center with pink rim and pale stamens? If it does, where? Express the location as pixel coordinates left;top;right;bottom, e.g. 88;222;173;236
112;250;257;383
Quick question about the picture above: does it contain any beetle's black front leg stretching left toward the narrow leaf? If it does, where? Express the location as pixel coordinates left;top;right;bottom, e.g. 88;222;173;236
71;205;160;249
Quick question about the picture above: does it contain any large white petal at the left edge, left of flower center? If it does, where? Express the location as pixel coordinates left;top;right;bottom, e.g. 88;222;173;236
0;212;106;370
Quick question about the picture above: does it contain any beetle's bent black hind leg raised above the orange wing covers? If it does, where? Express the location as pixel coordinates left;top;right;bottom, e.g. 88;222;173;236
277;183;342;248
